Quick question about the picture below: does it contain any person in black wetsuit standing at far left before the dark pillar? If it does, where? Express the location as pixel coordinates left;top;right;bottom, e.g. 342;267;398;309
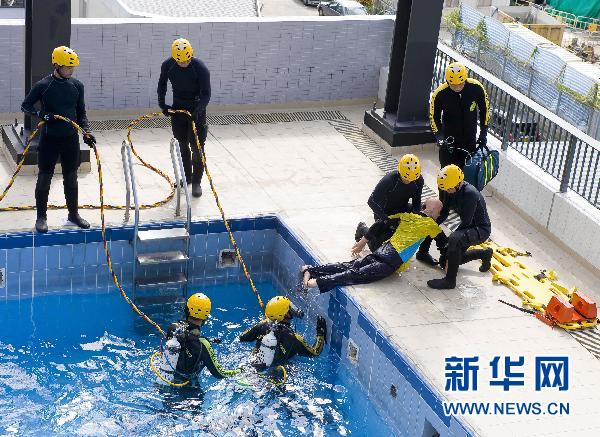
21;46;96;233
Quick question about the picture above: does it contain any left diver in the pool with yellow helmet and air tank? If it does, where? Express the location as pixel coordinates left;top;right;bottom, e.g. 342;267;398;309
158;293;240;387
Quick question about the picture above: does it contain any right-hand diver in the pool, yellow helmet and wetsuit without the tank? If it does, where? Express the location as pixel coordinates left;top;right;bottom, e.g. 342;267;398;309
239;296;327;366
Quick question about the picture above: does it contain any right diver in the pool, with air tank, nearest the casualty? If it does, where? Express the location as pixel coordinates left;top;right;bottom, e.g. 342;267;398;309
240;296;327;370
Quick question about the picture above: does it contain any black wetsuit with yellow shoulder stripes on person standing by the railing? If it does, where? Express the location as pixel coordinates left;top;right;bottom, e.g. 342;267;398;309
429;79;489;168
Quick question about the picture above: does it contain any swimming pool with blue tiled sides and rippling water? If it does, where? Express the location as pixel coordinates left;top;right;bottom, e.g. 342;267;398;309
0;216;471;437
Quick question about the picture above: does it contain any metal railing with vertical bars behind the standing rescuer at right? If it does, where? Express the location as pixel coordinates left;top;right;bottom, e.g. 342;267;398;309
432;43;600;209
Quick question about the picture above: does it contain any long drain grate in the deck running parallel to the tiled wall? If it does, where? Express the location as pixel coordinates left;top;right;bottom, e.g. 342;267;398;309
90;111;346;131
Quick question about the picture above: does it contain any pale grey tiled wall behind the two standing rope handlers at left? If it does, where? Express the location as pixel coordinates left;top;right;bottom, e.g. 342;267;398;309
0;16;394;112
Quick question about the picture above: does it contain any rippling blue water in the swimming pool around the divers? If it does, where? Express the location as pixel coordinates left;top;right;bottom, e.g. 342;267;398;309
0;283;393;436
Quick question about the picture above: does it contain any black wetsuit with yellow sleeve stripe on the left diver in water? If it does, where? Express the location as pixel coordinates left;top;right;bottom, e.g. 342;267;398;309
167;320;239;385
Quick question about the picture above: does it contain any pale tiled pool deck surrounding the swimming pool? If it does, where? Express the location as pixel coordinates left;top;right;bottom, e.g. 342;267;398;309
0;106;600;436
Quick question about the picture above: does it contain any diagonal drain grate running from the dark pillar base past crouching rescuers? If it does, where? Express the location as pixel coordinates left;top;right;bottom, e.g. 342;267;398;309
329;119;460;230
